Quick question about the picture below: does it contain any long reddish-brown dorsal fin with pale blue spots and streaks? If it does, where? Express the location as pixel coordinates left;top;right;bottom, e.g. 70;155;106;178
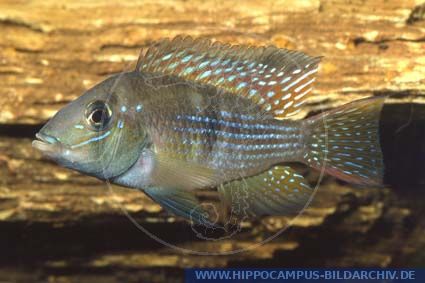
136;36;320;118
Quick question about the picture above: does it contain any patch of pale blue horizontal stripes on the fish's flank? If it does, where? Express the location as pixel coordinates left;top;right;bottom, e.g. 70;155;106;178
169;111;302;170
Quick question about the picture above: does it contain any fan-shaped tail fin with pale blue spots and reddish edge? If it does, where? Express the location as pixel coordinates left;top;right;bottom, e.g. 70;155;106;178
303;97;385;185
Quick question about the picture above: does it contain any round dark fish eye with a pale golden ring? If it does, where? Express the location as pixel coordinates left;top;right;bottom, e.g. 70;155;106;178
85;100;112;131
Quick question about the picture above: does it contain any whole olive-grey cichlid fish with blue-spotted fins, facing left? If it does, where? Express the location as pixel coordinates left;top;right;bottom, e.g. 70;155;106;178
33;37;384;222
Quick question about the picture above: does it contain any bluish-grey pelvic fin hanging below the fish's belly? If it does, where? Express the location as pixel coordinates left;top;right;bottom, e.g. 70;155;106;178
143;187;214;226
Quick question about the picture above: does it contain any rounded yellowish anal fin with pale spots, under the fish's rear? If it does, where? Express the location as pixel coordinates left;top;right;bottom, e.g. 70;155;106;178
219;166;313;219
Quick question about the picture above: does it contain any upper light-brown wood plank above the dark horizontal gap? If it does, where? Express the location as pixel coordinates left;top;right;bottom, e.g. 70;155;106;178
0;0;425;123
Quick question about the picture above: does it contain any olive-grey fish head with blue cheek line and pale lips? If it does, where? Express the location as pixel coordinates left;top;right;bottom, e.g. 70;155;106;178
32;73;146;179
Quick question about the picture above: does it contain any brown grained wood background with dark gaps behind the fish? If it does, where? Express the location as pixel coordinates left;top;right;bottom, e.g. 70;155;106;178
0;0;425;282
